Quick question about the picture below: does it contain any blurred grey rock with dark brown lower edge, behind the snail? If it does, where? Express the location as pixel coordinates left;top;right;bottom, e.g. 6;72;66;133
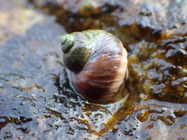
29;0;187;41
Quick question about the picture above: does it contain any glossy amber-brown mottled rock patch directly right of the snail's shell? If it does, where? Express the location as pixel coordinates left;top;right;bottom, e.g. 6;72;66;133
129;36;187;103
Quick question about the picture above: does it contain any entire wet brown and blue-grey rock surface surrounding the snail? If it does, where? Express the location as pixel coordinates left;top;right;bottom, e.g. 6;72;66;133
0;0;187;140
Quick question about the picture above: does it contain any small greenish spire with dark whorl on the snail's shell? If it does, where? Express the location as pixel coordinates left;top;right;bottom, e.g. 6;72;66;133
61;32;91;72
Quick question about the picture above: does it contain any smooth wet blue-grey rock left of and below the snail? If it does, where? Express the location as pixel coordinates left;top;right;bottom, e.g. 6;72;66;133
0;1;129;139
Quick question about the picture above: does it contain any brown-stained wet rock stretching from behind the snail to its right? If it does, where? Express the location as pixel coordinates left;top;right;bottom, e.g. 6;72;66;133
27;0;187;103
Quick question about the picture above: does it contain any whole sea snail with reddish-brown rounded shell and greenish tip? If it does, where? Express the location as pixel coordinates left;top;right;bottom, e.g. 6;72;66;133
61;30;127;101
